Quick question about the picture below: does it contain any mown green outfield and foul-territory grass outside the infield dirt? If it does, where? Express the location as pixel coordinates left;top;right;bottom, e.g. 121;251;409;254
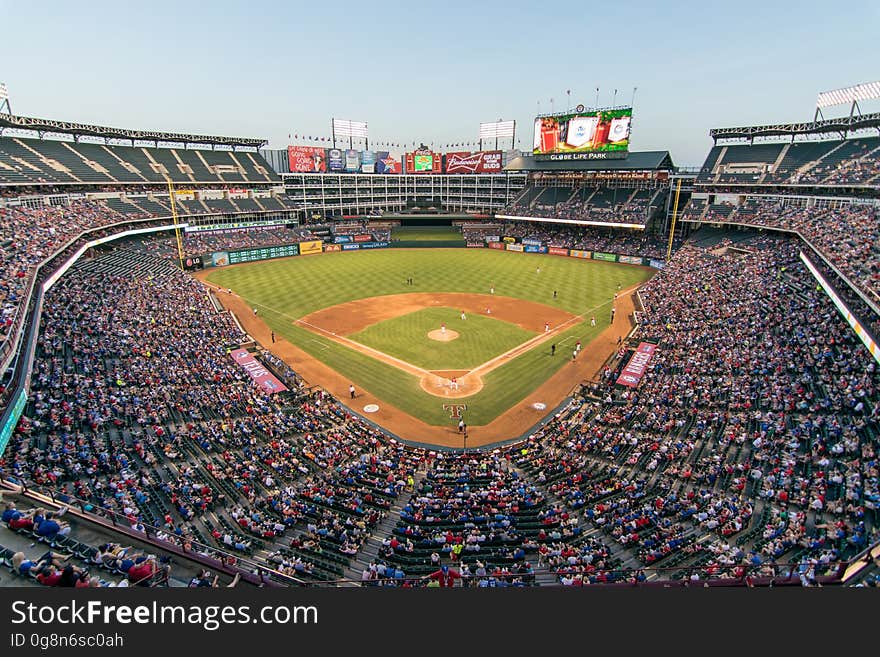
208;249;651;429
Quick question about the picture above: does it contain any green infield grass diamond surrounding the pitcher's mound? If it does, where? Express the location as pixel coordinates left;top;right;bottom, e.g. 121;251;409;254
347;308;536;370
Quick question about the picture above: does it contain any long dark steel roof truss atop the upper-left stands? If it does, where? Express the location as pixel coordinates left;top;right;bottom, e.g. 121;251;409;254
0;114;269;148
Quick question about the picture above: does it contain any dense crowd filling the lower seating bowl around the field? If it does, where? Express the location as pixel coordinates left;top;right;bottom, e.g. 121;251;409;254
0;197;880;586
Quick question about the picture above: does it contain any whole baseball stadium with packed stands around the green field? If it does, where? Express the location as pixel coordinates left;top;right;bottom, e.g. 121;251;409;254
0;9;880;600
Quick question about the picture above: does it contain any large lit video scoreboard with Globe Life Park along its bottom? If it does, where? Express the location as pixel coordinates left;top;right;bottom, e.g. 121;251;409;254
533;107;632;160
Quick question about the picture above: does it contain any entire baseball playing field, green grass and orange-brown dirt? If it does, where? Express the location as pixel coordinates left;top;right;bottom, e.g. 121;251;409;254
202;249;653;442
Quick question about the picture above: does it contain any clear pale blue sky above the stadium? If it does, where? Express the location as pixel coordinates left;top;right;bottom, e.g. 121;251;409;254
0;0;880;166
